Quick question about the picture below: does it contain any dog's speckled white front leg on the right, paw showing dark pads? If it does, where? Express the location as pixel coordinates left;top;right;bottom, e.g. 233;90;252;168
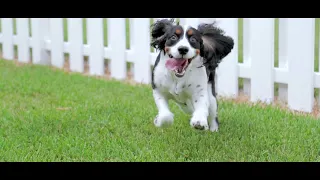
190;86;209;130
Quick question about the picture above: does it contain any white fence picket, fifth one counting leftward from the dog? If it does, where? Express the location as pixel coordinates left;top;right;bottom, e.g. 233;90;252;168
50;18;64;68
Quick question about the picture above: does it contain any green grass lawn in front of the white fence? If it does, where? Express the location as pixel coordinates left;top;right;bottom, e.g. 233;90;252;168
0;60;320;162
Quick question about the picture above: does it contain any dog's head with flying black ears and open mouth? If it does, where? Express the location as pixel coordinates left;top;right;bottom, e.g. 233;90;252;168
151;19;234;77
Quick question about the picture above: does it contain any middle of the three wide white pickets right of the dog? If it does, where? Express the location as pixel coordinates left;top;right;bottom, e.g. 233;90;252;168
250;18;274;103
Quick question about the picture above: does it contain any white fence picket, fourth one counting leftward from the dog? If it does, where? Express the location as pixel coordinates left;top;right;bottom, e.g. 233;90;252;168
68;18;84;72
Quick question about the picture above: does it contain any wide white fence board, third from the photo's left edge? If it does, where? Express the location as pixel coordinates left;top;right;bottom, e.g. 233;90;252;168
31;18;50;65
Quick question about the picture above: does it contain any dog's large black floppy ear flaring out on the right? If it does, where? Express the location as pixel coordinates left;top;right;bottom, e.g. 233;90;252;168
198;22;234;68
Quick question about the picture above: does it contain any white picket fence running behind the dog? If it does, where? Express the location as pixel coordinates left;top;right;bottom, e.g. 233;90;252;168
0;18;320;112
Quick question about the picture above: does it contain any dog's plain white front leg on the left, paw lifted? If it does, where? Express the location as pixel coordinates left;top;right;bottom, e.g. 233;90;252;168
153;89;173;127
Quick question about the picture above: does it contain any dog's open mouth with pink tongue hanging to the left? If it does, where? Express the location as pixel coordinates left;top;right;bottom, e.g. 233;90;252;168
166;54;195;77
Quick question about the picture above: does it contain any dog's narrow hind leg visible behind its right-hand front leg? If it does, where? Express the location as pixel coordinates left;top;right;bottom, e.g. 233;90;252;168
208;83;219;132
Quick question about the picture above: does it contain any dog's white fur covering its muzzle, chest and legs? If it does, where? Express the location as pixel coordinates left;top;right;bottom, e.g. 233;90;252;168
153;48;218;131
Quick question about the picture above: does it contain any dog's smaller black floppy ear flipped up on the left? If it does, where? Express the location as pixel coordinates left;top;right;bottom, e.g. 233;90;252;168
151;18;174;50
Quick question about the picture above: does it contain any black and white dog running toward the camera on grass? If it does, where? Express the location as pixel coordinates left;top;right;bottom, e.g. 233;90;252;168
151;19;234;131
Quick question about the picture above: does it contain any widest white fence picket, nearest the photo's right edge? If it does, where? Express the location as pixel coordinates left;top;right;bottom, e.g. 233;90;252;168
287;18;315;112
